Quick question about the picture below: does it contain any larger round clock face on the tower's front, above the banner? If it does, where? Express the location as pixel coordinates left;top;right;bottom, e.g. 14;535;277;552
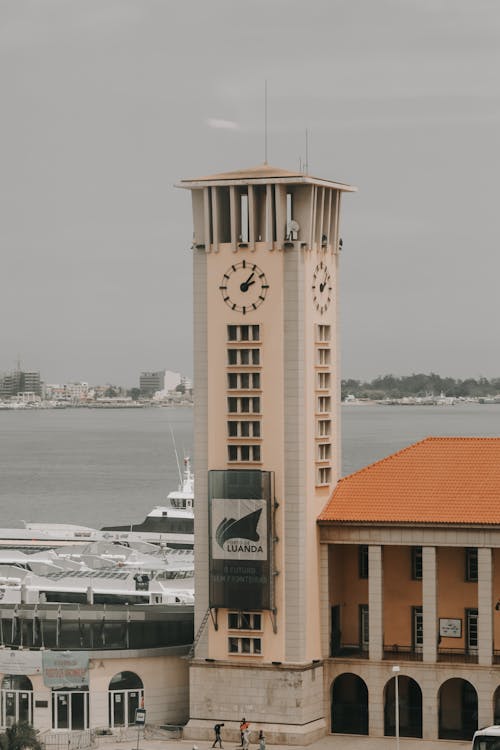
219;260;269;315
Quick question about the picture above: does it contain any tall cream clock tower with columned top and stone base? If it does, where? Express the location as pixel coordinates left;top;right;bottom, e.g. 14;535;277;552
179;164;353;744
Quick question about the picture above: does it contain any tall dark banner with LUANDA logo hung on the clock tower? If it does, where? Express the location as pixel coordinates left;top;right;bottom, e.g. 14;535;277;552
209;469;272;610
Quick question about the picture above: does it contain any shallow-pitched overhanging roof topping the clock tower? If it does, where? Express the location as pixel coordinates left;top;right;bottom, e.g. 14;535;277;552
176;164;356;192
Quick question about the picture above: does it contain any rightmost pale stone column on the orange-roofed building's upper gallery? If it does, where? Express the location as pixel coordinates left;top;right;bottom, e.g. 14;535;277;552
477;547;494;668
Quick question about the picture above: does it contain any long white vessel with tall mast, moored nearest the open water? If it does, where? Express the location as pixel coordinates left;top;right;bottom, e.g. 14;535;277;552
0;458;194;549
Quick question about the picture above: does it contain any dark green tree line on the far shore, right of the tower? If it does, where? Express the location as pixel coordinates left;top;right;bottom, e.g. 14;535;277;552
341;372;500;400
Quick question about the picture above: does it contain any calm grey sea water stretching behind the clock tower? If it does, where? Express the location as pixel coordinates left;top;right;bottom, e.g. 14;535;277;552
0;404;500;527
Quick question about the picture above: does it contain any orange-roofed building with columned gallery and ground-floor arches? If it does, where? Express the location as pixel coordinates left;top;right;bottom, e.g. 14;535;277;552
319;438;500;740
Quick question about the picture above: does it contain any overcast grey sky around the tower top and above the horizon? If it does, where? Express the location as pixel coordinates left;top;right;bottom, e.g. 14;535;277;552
0;0;500;386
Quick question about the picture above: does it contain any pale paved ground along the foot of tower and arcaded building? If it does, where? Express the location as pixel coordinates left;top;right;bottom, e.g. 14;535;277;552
96;734;470;750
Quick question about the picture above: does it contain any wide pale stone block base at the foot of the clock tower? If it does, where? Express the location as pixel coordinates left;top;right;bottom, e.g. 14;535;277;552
184;661;327;745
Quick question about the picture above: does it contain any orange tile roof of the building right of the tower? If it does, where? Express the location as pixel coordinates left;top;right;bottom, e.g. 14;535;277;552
318;437;500;525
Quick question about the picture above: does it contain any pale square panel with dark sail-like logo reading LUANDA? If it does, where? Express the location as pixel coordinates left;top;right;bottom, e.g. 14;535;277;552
212;498;267;560
